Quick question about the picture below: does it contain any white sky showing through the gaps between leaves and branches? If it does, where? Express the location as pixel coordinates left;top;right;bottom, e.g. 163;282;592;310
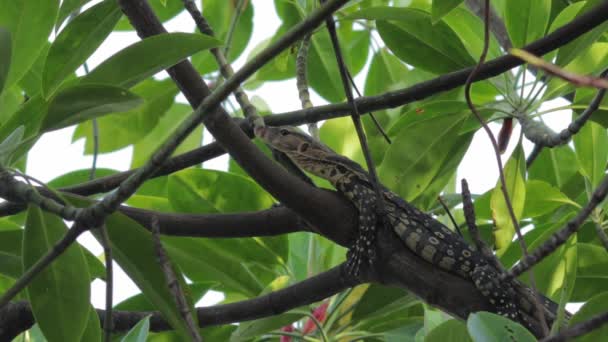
27;0;570;308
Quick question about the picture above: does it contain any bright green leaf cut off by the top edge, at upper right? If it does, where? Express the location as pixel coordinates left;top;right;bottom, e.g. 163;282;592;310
505;0;551;47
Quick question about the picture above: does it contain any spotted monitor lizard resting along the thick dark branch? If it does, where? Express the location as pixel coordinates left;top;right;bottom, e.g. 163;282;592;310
256;126;557;328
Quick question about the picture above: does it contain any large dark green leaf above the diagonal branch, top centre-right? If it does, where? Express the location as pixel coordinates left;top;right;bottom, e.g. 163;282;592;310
348;7;475;74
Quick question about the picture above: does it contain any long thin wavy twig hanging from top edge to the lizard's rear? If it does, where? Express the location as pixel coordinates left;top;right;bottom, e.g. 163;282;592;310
464;0;549;335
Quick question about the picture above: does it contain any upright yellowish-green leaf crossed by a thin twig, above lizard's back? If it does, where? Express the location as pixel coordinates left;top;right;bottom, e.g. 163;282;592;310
490;147;526;255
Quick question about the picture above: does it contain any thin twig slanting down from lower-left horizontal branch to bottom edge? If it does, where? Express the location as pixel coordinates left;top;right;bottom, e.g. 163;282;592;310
151;216;202;342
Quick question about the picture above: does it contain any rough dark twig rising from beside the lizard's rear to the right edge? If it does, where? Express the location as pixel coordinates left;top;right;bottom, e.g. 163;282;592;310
503;176;608;279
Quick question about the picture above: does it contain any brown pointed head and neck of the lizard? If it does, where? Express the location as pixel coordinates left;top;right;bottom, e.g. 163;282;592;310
255;126;364;184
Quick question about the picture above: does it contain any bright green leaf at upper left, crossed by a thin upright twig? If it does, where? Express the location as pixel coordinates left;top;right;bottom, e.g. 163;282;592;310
72;79;178;154
